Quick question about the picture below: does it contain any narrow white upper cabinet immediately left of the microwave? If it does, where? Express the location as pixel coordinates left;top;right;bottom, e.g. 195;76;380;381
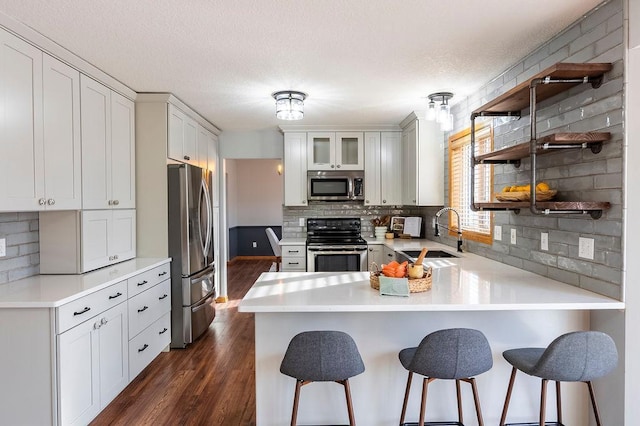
284;132;307;206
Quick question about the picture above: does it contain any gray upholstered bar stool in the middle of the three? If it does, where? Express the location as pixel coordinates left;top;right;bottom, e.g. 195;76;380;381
398;328;493;426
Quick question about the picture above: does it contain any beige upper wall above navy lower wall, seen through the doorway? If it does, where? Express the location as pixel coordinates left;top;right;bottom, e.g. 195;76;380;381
235;159;284;226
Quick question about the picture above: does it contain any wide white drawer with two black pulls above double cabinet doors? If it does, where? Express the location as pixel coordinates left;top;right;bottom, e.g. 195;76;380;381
56;281;127;334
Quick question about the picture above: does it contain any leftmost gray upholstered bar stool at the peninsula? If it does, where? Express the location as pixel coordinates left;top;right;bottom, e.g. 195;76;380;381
280;331;364;426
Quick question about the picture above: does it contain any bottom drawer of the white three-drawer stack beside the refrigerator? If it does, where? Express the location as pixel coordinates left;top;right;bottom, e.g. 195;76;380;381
129;312;171;381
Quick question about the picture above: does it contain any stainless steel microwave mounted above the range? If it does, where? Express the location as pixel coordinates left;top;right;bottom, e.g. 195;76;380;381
307;171;364;201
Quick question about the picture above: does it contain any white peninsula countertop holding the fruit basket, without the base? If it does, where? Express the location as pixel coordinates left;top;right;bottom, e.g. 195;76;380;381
238;243;624;312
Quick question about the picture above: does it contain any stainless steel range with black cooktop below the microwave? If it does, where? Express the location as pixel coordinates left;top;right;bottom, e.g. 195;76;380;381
307;217;367;272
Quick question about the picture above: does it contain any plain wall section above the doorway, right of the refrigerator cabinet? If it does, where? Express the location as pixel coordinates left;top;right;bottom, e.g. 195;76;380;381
220;129;284;159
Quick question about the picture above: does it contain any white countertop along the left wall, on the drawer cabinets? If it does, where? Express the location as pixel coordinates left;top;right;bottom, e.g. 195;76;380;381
0;258;171;308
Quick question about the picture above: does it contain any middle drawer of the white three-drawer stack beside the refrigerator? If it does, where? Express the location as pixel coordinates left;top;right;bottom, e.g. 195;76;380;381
129;280;171;338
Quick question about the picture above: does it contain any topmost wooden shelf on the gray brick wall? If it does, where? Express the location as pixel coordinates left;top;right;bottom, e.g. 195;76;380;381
473;62;612;114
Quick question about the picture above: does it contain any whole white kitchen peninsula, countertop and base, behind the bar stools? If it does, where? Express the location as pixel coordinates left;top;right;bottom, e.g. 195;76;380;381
239;240;624;426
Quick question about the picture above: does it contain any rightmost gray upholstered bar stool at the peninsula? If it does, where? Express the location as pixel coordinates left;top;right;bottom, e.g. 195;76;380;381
500;331;618;426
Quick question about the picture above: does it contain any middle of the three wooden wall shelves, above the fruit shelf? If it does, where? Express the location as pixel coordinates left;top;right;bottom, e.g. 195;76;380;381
475;132;611;164
